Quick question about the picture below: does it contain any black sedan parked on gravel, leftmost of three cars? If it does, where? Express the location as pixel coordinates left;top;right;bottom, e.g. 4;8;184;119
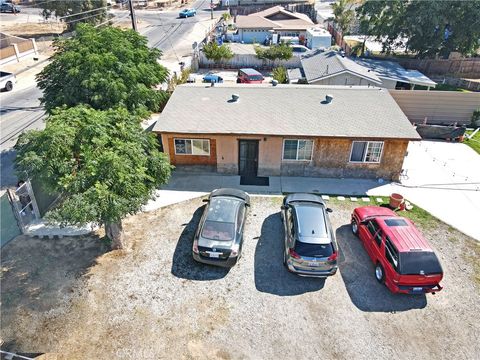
192;189;250;267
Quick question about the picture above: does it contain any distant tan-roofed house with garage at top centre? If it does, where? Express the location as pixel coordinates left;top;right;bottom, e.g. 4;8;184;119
235;6;314;43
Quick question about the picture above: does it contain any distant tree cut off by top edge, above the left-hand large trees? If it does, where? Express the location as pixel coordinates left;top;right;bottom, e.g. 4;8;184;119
38;0;108;31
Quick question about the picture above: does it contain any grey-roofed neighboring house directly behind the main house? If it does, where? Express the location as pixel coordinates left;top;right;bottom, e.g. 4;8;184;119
290;51;436;89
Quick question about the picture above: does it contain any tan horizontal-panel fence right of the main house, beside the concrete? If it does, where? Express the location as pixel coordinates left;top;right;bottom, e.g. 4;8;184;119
389;90;480;125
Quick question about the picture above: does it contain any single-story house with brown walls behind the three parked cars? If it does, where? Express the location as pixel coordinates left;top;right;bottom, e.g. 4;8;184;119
153;84;420;179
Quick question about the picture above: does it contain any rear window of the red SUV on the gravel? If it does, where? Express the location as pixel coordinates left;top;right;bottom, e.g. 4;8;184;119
400;251;443;275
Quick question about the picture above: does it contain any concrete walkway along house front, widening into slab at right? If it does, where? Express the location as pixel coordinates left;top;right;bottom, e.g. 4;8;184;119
145;141;480;240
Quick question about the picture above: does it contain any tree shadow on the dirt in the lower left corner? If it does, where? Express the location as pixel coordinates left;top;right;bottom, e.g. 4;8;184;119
1;235;109;351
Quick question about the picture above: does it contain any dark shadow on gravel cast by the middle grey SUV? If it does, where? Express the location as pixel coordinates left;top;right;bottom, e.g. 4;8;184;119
255;212;325;296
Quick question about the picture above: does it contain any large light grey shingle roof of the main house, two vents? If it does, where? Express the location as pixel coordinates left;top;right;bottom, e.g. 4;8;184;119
153;84;420;139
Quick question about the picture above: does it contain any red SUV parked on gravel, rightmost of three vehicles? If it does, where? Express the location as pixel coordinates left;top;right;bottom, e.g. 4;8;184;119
351;206;443;294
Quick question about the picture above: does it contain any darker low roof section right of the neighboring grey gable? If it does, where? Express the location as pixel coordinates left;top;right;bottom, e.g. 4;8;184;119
353;58;437;86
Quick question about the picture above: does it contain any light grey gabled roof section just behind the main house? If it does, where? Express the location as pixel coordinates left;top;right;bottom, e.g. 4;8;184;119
301;51;382;84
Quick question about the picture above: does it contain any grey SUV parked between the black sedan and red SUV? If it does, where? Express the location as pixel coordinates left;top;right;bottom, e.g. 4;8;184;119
282;193;338;277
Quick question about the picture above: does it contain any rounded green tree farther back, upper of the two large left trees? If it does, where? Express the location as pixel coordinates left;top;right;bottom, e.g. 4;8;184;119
37;24;168;112
